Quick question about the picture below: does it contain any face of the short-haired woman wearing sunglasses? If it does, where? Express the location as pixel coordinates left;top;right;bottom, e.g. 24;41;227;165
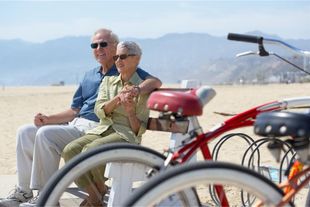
113;47;140;74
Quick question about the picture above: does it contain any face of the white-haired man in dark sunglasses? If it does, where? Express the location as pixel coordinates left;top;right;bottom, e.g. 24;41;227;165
92;33;116;65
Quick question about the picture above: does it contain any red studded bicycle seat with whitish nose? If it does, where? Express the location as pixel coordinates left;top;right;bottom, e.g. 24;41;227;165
147;87;215;116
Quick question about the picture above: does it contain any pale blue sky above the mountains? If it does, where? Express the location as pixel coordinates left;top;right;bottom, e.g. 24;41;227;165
0;0;310;42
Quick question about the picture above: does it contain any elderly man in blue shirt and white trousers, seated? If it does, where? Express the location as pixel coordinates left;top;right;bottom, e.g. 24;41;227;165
0;29;161;207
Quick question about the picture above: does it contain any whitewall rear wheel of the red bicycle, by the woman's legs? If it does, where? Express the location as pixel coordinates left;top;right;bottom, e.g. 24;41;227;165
38;143;199;206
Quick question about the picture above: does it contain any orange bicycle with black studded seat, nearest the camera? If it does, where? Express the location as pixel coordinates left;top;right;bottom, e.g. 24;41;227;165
125;112;310;206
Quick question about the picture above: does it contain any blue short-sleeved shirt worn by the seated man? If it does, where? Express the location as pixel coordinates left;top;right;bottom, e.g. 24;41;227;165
71;65;150;122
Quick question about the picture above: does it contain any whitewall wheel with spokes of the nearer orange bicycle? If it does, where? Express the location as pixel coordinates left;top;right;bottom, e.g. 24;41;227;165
123;161;283;206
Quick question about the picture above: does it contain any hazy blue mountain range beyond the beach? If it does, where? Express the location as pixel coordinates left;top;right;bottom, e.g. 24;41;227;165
0;31;310;86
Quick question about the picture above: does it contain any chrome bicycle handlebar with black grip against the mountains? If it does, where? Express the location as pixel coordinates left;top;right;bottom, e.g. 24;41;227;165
227;33;310;57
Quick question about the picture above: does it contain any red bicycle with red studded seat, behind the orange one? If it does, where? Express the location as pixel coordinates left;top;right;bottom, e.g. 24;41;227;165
39;33;310;206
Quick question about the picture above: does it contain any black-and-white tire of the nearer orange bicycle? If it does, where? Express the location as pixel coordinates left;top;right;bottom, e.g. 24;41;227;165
123;161;283;206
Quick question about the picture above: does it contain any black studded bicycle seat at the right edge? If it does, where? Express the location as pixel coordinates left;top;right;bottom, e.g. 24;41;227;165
254;112;310;138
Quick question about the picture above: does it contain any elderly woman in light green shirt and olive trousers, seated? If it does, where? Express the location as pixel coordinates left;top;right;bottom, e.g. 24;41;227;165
63;41;149;206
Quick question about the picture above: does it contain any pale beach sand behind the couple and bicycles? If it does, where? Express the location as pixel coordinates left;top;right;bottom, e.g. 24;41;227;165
0;84;310;205
